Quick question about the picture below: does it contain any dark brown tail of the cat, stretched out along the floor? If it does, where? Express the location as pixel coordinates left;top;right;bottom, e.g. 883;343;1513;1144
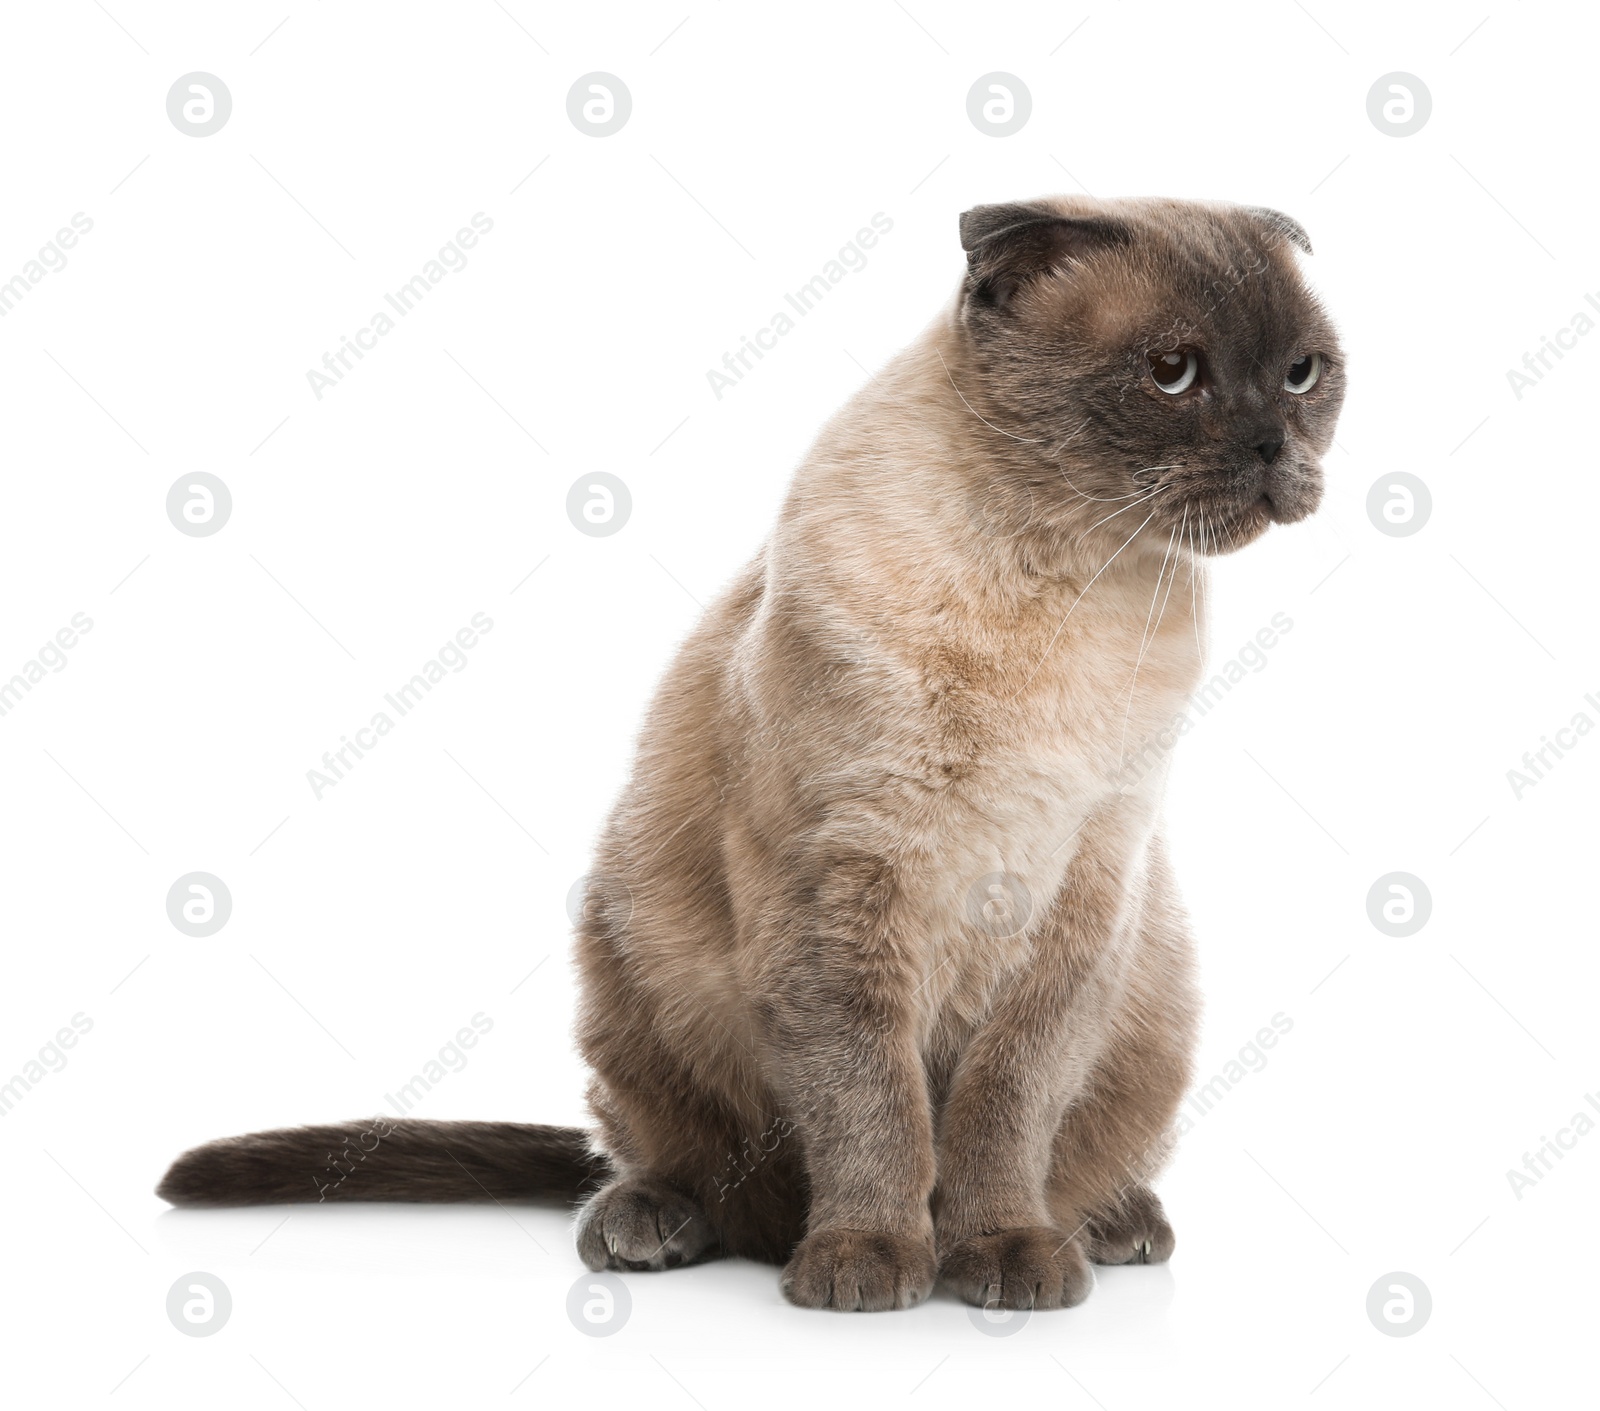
155;1117;611;1206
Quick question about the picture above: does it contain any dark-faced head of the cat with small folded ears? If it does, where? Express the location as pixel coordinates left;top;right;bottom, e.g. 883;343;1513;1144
952;197;1344;554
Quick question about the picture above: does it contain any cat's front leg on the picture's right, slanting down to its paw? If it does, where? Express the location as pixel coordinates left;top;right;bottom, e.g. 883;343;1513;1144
936;817;1144;1309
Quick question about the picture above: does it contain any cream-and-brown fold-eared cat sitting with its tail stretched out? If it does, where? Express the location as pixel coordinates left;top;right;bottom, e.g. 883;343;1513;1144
158;197;1346;1310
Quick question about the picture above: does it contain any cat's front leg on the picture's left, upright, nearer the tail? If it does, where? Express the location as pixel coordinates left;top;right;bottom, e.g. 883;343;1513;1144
758;854;936;1312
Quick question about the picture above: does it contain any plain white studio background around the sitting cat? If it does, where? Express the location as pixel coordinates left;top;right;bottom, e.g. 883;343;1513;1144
0;0;1600;1411
